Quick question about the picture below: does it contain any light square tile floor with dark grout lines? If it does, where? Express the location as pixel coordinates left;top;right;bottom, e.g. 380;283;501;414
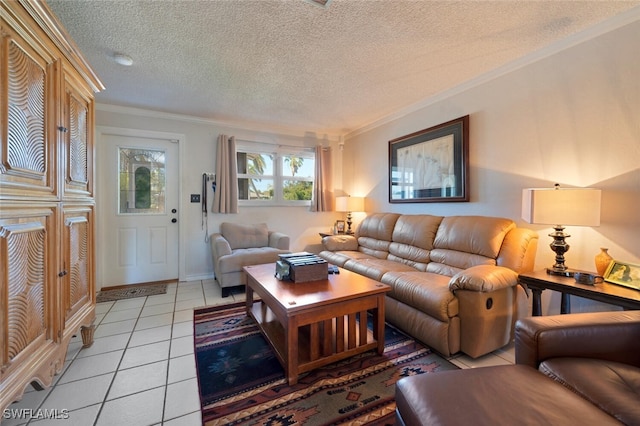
0;280;515;426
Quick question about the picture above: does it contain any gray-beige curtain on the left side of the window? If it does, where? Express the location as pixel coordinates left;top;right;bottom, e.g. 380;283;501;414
211;135;238;213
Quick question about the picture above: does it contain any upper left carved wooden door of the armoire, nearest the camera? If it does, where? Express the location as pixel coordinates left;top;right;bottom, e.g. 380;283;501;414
0;27;57;198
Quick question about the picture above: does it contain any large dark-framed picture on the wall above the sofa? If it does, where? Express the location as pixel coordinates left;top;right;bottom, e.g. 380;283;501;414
389;115;469;203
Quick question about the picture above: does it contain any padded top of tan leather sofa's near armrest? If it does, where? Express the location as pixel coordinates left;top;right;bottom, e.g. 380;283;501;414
449;265;518;292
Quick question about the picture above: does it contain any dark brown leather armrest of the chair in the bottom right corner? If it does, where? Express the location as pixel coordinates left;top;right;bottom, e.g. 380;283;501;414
515;311;640;368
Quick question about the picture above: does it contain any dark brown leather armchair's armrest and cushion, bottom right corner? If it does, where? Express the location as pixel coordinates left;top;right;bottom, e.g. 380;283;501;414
516;311;640;425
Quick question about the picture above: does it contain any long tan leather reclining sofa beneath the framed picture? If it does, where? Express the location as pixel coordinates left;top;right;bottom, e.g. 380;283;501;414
320;213;538;358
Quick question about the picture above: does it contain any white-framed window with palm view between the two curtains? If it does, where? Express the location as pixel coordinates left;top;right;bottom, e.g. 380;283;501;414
236;144;315;206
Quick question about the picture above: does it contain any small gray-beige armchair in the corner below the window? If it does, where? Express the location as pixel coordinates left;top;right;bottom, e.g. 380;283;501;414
210;222;290;297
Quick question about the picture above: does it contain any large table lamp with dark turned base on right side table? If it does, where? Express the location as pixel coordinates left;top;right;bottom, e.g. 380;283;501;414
522;184;601;277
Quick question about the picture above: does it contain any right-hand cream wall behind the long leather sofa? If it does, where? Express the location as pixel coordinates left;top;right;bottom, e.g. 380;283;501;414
343;17;640;312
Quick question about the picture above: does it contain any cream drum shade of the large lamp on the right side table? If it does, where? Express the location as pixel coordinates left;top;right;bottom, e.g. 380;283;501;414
522;188;601;226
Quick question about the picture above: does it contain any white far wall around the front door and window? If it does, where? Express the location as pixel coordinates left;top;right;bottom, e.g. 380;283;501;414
96;110;340;286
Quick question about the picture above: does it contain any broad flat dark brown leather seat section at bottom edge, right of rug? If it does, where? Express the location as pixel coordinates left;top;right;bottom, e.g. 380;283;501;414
396;365;620;426
